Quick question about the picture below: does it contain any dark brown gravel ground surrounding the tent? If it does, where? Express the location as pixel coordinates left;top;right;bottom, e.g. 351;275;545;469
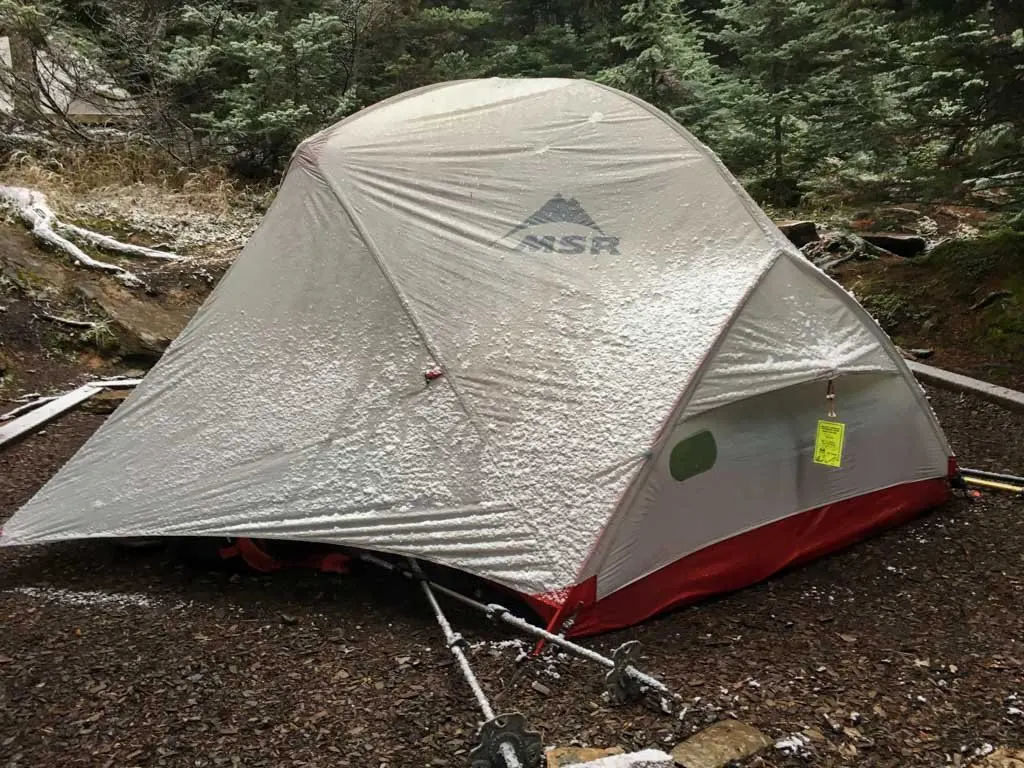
0;391;1024;768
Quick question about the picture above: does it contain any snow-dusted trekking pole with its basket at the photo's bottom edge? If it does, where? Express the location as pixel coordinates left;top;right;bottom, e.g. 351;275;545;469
410;558;544;768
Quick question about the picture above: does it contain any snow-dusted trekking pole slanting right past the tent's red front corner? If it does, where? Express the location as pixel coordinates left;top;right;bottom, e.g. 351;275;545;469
360;554;680;712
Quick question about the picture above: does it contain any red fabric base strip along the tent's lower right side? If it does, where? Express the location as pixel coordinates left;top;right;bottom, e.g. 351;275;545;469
530;478;951;637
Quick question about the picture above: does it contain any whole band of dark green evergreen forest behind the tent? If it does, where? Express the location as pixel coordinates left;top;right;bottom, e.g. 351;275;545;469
0;0;1024;198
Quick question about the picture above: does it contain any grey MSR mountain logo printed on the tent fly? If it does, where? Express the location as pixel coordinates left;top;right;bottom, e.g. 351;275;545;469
502;195;620;256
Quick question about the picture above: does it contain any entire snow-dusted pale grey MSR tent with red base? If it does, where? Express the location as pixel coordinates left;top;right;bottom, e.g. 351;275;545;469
0;79;953;635
